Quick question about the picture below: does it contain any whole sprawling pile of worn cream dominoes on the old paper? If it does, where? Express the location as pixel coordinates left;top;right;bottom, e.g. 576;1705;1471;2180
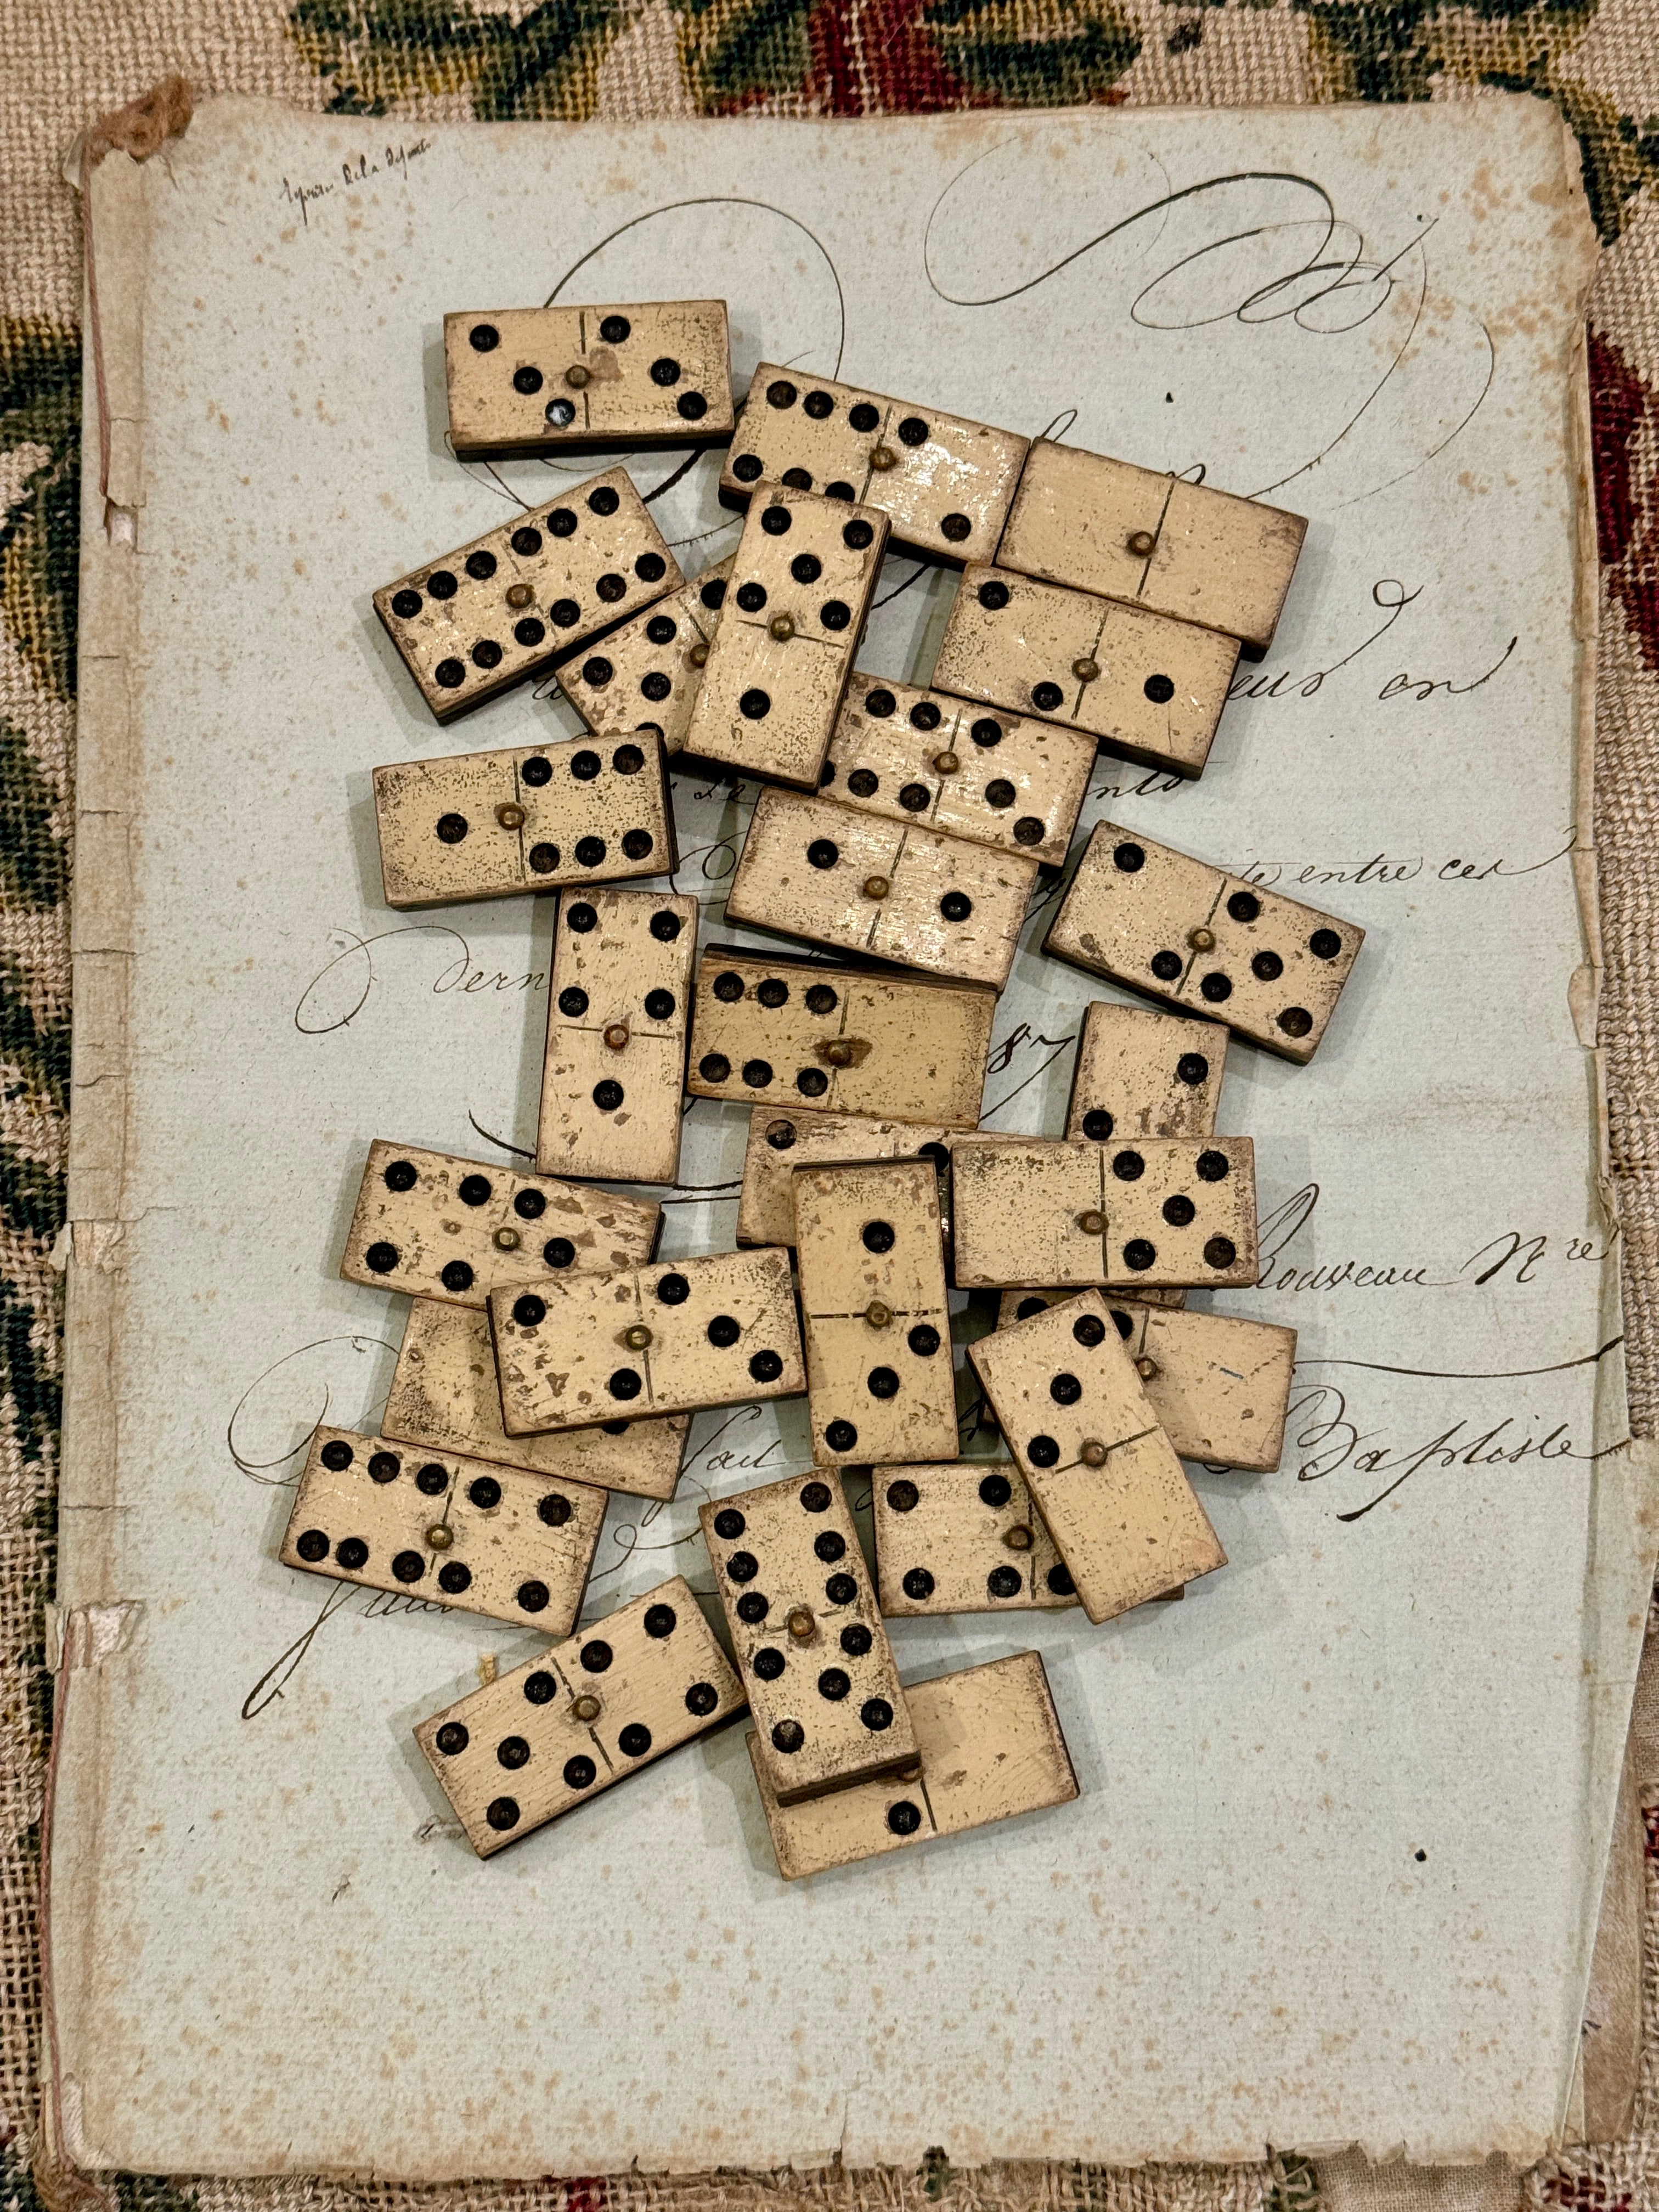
283;301;1363;1878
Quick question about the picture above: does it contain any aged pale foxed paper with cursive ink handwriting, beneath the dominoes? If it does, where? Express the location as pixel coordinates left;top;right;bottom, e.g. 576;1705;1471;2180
49;95;1652;2179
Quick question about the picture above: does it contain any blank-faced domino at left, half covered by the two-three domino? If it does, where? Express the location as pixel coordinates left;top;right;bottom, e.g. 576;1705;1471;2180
381;1299;690;1500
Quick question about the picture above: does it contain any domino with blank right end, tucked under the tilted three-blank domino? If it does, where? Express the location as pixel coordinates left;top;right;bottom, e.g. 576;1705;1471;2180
997;1290;1296;1475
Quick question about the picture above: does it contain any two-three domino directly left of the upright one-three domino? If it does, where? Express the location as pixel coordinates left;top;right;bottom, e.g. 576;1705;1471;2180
489;1248;808;1436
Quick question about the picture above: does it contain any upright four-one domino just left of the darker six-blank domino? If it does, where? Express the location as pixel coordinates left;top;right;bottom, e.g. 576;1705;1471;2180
535;891;697;1186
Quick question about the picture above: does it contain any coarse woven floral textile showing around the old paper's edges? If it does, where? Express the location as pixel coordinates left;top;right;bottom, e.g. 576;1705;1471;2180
0;13;1659;2212
